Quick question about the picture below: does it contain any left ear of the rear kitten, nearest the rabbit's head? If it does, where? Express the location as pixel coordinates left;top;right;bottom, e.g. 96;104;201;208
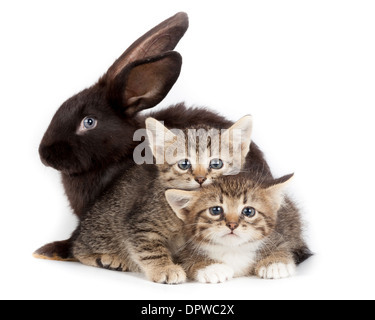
146;118;177;159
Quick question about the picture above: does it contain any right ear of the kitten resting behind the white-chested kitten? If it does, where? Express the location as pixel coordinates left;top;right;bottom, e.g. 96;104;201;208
222;115;253;157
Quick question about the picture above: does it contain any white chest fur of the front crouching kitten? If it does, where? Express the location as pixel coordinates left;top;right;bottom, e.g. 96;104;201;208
205;242;261;277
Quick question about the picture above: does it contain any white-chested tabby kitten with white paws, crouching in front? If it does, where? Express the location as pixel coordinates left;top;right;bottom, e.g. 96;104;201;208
166;174;310;283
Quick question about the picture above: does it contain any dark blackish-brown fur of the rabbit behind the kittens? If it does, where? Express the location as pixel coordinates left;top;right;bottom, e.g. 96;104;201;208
34;13;271;260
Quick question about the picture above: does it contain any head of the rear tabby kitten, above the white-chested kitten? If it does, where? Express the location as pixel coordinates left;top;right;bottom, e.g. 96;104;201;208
146;116;252;190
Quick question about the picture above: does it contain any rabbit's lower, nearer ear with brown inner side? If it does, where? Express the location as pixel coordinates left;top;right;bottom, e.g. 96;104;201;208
107;51;182;116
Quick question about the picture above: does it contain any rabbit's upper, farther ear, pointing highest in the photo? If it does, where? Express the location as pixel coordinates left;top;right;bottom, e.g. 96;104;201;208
105;12;189;82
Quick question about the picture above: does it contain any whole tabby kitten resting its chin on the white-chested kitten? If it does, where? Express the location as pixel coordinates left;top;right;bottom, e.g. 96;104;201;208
73;117;252;284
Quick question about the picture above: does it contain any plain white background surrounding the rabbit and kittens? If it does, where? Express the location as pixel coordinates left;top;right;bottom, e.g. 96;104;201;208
0;0;375;300
